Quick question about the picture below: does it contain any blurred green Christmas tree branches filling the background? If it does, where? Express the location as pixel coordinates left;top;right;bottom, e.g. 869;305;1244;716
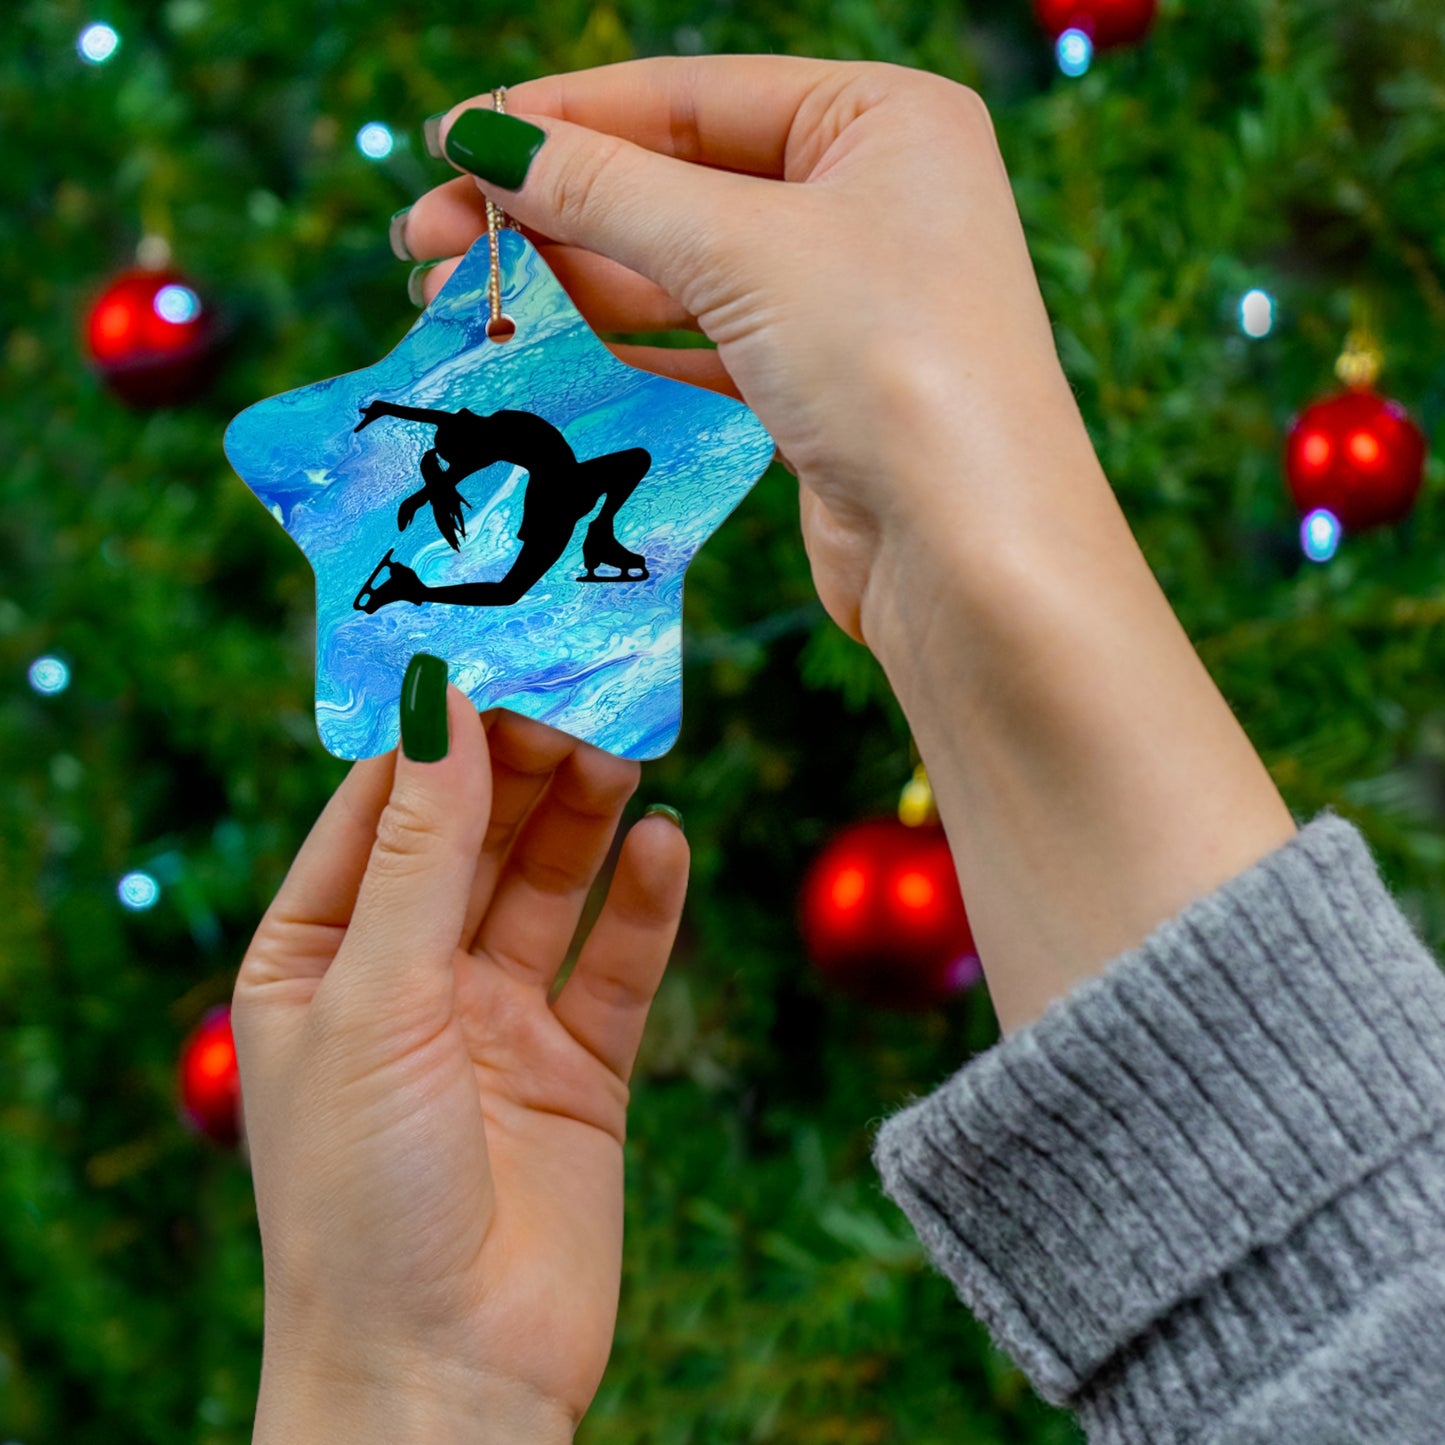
0;0;1445;1445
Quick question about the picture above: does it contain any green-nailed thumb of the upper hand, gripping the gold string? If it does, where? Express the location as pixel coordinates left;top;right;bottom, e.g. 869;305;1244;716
439;105;769;315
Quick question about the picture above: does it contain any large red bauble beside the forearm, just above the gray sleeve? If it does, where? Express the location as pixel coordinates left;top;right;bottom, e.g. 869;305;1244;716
802;818;980;1009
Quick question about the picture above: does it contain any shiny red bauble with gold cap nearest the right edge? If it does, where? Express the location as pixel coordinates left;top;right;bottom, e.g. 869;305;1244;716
1285;387;1425;532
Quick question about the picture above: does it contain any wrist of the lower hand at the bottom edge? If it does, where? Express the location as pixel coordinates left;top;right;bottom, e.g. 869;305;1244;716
251;1355;577;1445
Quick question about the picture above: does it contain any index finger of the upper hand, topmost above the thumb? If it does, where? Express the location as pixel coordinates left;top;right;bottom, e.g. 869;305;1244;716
456;55;855;179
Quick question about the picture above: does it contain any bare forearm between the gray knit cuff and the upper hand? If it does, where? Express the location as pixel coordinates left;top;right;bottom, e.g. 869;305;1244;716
863;367;1295;1032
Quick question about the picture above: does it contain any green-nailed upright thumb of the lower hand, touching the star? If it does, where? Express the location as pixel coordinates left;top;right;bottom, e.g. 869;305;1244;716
322;653;491;1027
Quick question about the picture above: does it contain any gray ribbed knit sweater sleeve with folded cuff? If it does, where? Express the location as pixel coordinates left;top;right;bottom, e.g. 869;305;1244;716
873;814;1445;1445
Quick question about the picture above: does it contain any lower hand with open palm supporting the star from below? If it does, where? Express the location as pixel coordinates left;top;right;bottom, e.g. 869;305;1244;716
231;688;688;1441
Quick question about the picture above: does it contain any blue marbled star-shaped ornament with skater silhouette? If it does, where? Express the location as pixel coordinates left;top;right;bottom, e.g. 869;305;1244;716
225;230;773;759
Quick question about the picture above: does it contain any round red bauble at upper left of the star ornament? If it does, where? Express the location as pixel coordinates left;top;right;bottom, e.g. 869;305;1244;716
85;270;217;407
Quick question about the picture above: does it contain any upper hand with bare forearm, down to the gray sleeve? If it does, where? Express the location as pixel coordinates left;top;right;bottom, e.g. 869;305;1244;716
405;56;1293;1029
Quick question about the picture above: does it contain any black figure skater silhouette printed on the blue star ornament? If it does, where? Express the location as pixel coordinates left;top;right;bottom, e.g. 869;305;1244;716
351;402;652;613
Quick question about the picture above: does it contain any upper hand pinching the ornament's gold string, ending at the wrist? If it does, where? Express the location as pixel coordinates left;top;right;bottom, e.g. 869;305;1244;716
405;56;1107;650
